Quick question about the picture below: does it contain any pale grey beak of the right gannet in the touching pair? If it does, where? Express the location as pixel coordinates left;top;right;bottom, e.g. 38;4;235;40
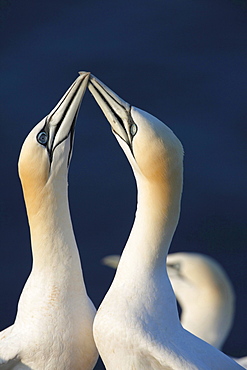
88;75;132;145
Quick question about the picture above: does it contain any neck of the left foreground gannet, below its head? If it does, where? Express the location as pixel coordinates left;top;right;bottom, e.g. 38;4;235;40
25;178;79;273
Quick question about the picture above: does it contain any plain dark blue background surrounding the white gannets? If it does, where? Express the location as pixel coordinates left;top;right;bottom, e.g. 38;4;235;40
0;0;247;369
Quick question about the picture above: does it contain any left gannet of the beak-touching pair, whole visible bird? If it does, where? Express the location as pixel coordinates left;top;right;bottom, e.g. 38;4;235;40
0;73;98;370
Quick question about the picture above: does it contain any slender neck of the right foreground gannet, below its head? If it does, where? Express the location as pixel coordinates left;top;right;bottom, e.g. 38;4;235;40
117;159;182;273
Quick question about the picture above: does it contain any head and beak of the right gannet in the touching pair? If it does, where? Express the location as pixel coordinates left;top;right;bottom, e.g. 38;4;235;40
88;77;183;182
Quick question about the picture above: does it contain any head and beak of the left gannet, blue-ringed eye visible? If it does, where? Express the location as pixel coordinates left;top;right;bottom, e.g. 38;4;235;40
18;72;89;199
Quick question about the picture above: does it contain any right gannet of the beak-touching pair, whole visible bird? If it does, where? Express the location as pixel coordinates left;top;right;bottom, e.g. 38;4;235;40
88;78;241;370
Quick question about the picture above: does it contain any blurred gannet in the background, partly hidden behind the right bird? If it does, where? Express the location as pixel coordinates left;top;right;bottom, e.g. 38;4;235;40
102;252;235;349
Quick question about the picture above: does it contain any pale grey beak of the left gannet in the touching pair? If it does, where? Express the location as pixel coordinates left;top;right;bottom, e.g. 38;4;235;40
37;72;90;162
